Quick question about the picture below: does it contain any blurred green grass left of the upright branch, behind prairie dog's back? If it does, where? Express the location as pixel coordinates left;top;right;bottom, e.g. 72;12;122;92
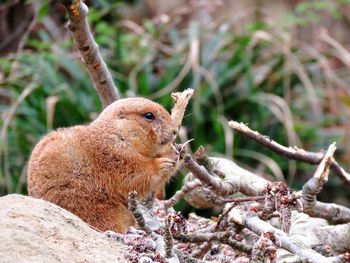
0;34;101;193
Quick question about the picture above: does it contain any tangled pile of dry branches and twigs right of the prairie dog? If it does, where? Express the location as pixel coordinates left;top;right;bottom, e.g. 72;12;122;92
113;132;350;262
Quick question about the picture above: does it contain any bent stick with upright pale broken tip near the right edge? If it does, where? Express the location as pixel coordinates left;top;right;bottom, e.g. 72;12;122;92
301;143;350;223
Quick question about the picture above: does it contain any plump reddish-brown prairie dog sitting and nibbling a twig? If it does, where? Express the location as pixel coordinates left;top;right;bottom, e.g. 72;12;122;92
28;98;177;232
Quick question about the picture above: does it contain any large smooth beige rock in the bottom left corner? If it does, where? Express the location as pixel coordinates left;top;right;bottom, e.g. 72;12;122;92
0;194;129;263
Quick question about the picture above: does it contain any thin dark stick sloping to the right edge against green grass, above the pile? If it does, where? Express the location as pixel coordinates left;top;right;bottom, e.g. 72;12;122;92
228;121;350;185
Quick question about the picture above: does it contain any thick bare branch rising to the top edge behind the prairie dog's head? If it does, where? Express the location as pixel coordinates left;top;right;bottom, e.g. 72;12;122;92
61;0;120;107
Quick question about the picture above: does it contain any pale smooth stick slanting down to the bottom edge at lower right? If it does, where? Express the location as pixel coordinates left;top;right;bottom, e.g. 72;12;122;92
229;208;332;263
